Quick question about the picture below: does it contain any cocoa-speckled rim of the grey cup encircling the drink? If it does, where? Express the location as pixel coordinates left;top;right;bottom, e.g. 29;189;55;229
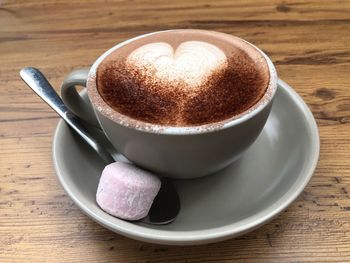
87;29;278;135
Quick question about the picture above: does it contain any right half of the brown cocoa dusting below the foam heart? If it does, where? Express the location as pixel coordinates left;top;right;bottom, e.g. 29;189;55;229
183;55;269;125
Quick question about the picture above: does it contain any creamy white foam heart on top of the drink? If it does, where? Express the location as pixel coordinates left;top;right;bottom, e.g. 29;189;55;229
126;41;227;88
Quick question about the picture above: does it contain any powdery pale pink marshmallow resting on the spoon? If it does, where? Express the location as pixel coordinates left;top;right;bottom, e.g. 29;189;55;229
96;162;161;220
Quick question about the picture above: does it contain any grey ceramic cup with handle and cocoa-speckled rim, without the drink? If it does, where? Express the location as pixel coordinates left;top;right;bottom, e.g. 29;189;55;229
61;29;277;179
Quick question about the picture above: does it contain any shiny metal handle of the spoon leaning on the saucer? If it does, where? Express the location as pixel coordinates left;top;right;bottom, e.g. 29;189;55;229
20;67;114;164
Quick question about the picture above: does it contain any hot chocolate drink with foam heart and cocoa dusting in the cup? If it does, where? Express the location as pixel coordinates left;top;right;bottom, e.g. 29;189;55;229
96;30;269;126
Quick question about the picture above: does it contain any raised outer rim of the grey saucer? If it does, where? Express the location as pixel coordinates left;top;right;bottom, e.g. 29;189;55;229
52;79;320;245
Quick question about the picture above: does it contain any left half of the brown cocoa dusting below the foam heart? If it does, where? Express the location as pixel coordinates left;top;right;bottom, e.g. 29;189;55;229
97;63;186;125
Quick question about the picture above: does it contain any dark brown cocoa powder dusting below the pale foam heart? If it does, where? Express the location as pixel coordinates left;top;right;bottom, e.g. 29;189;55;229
97;53;269;126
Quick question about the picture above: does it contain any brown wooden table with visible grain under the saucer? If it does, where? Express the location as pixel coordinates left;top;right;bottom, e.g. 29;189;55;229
0;0;350;262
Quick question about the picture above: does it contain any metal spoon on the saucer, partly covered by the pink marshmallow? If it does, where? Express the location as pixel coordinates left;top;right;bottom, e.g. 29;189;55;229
20;67;180;225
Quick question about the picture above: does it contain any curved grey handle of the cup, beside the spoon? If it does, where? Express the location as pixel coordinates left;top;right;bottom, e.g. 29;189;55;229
61;68;101;129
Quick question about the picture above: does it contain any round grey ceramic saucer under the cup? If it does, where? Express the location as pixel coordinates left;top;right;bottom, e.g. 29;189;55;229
53;81;319;245
